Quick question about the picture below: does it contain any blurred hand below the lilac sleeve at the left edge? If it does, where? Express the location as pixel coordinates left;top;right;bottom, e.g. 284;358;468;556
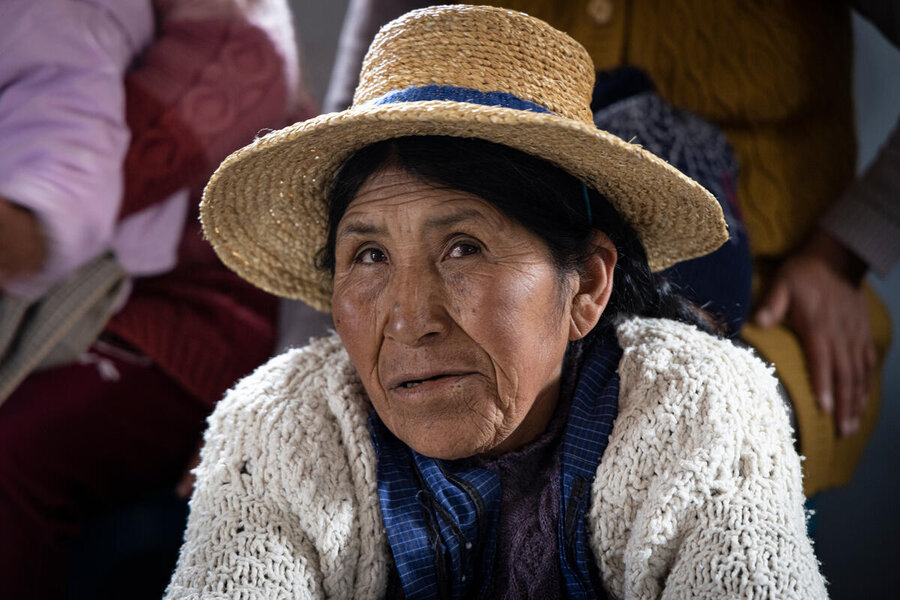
0;196;47;286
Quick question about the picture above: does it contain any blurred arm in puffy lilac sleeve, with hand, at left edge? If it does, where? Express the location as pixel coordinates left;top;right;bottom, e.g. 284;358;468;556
0;0;152;297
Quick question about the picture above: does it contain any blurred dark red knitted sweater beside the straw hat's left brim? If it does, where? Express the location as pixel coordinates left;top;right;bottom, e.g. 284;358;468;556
109;3;311;404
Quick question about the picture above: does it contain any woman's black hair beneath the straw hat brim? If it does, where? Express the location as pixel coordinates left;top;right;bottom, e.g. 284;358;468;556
317;136;711;338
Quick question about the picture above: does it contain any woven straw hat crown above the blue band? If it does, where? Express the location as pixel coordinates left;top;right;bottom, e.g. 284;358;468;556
353;5;594;123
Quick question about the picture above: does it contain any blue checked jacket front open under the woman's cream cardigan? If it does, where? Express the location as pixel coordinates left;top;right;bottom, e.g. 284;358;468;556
369;339;622;600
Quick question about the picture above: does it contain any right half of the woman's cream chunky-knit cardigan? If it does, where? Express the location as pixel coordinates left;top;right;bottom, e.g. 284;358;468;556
589;319;827;600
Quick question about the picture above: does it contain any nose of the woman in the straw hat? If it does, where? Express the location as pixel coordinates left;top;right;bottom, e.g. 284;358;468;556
385;267;450;346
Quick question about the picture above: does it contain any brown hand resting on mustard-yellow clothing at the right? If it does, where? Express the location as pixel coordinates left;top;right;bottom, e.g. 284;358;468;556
755;231;876;435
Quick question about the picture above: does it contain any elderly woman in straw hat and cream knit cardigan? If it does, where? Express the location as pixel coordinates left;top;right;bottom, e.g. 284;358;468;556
168;6;825;598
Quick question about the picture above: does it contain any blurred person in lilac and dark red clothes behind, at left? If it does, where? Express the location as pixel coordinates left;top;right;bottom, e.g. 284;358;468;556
0;0;301;599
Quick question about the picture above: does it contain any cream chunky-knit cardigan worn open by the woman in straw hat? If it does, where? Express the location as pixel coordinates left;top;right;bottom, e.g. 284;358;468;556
166;319;826;600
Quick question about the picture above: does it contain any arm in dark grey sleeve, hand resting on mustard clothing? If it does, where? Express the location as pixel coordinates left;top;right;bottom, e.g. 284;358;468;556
756;0;900;435
